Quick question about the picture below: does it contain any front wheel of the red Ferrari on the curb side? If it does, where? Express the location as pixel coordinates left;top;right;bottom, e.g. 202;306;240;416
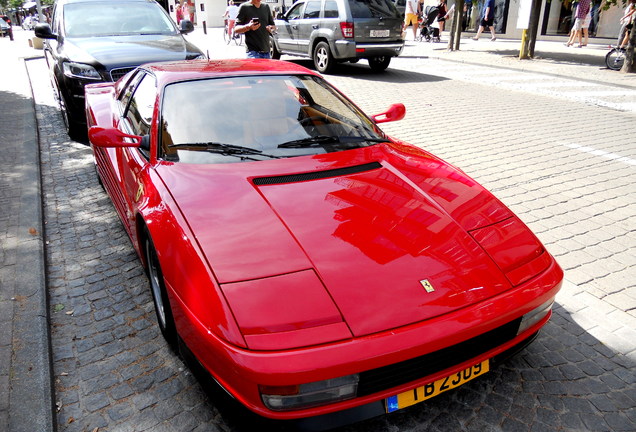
144;229;179;352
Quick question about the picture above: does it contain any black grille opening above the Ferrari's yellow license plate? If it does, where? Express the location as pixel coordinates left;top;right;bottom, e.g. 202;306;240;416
358;318;521;396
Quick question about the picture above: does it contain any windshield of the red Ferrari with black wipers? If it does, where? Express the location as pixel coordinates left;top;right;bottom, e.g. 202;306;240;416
160;76;387;163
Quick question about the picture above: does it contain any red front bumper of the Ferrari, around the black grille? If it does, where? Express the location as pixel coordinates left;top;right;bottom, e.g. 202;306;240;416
172;261;563;421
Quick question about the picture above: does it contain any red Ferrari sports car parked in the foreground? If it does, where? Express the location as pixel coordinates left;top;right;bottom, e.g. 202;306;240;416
86;60;563;426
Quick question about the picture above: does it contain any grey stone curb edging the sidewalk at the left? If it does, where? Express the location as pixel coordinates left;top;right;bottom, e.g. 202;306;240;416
9;59;56;432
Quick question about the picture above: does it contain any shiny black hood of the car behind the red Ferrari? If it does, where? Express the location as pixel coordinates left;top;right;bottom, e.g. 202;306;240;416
64;35;201;70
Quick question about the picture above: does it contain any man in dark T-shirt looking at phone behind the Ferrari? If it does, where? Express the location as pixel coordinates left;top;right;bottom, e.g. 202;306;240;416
234;0;276;58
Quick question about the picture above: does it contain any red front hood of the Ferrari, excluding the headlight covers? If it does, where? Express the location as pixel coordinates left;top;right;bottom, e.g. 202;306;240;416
158;145;511;336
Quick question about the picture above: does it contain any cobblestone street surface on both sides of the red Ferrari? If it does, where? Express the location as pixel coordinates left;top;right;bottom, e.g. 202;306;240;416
16;25;636;432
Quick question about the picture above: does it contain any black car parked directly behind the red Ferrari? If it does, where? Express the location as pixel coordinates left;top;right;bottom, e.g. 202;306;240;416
35;0;205;140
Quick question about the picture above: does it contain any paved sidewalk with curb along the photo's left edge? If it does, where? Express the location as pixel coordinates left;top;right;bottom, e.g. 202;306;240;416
0;27;56;432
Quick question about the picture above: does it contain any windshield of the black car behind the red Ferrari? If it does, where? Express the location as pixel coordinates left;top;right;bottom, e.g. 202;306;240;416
64;2;177;37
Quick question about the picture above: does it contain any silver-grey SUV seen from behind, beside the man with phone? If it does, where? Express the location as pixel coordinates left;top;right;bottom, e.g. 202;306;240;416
271;0;404;73
